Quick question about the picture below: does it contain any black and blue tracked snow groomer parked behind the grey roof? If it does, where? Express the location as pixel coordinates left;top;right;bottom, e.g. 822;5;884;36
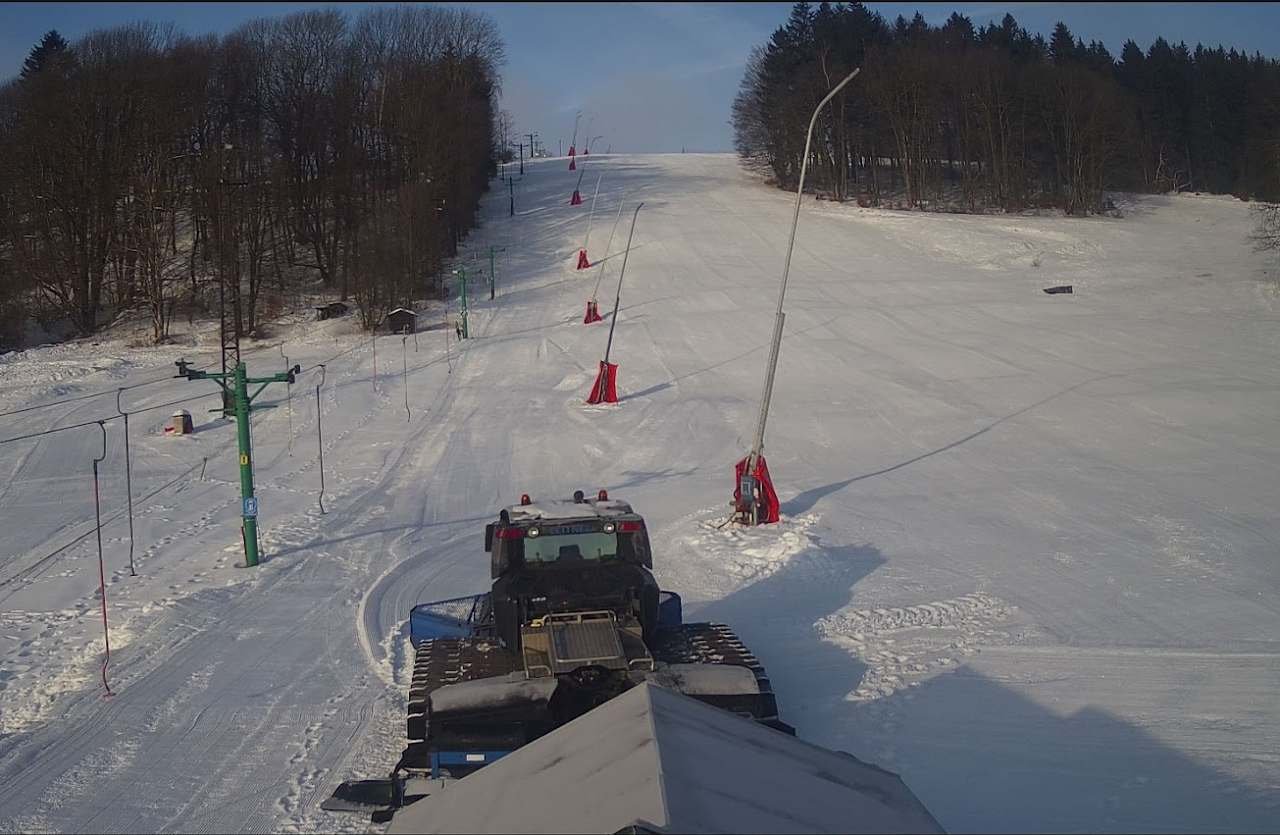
322;490;795;809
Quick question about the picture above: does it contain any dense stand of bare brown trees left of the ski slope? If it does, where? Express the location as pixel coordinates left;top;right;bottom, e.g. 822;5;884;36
0;6;503;342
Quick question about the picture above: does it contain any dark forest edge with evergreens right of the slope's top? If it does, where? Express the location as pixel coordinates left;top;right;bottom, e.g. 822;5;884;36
732;3;1280;214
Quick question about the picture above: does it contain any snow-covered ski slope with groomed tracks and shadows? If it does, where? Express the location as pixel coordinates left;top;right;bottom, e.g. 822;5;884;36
0;155;1280;831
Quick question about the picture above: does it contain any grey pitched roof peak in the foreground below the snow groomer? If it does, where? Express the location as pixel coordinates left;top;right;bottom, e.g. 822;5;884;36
388;683;943;835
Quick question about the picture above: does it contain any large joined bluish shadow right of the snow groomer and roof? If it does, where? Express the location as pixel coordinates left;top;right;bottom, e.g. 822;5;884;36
686;543;1280;832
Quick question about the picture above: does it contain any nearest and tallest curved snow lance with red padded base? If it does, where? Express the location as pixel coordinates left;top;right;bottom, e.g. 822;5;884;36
733;67;861;525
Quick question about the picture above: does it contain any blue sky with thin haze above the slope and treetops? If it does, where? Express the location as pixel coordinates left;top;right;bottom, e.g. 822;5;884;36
0;3;1280;152
